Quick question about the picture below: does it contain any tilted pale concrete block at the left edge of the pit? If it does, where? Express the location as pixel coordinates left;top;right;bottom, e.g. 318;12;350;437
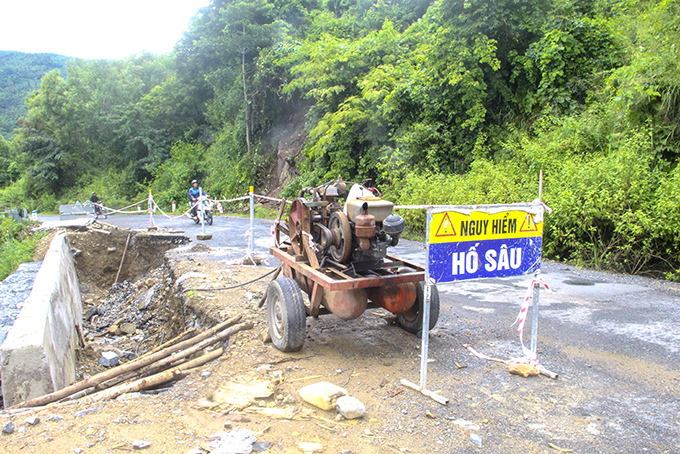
0;233;83;407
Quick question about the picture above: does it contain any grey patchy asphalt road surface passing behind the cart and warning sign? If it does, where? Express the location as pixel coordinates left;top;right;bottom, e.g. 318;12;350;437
41;216;680;452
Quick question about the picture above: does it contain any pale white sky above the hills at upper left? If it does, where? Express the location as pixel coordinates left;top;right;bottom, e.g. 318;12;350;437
0;0;210;60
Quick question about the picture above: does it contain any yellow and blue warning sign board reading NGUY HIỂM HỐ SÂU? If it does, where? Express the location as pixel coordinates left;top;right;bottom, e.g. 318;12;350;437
428;205;543;282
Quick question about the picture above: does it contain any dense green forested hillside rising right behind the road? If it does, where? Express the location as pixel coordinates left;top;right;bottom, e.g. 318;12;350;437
0;0;680;278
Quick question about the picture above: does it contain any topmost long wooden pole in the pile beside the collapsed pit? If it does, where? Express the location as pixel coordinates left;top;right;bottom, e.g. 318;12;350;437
11;315;241;408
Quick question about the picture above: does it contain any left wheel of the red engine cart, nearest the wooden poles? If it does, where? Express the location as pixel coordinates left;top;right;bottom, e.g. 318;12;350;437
267;277;307;352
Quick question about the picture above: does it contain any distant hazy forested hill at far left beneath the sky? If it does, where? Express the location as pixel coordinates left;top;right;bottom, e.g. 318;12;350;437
0;51;69;140
